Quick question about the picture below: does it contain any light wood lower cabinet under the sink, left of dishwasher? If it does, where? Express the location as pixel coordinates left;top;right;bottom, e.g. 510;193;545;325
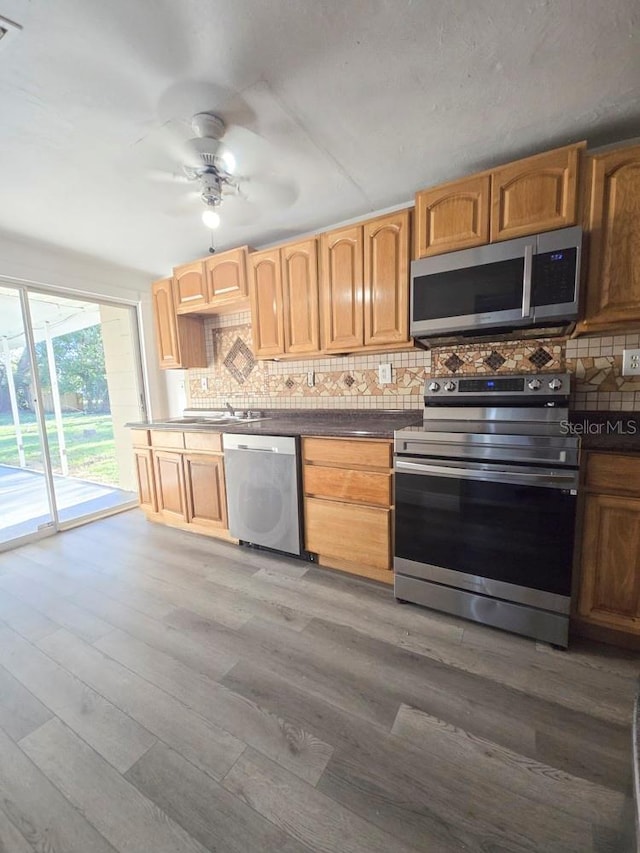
133;429;230;539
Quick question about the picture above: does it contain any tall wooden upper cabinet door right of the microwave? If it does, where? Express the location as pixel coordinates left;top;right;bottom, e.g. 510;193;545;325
585;146;640;326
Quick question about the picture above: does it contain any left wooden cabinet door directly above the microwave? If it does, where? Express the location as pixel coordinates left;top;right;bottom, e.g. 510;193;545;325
415;175;491;258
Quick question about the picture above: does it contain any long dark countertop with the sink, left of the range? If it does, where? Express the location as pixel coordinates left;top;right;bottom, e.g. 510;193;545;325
127;409;422;438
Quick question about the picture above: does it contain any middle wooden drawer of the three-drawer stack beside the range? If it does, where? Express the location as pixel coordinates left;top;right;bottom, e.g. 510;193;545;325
304;465;391;507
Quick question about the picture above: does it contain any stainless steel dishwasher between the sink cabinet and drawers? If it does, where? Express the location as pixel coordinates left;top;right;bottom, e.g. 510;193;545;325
222;433;302;555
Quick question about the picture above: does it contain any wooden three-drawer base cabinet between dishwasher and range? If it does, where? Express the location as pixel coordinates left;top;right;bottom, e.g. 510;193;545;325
302;438;393;583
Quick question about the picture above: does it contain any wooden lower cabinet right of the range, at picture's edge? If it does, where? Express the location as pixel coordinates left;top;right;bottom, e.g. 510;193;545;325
578;453;640;639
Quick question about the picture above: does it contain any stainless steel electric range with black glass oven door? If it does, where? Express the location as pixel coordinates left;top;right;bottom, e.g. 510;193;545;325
394;373;579;647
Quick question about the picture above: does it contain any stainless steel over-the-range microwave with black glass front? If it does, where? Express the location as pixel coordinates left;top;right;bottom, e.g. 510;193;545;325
411;227;582;338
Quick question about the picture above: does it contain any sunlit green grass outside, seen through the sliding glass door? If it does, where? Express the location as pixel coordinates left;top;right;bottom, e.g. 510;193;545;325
0;411;119;486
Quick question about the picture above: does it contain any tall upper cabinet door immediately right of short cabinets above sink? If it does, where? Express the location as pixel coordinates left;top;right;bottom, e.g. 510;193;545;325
249;249;284;357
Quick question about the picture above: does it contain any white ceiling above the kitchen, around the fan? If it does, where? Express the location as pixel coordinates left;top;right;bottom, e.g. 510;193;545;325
0;0;640;275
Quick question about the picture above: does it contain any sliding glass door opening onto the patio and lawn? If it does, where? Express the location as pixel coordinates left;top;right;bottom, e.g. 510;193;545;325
0;280;144;547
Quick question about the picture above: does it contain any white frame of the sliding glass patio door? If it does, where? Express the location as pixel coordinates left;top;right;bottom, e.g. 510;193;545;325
0;275;149;553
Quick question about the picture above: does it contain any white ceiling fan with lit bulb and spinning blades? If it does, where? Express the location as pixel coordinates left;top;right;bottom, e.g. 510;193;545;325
152;111;297;229
